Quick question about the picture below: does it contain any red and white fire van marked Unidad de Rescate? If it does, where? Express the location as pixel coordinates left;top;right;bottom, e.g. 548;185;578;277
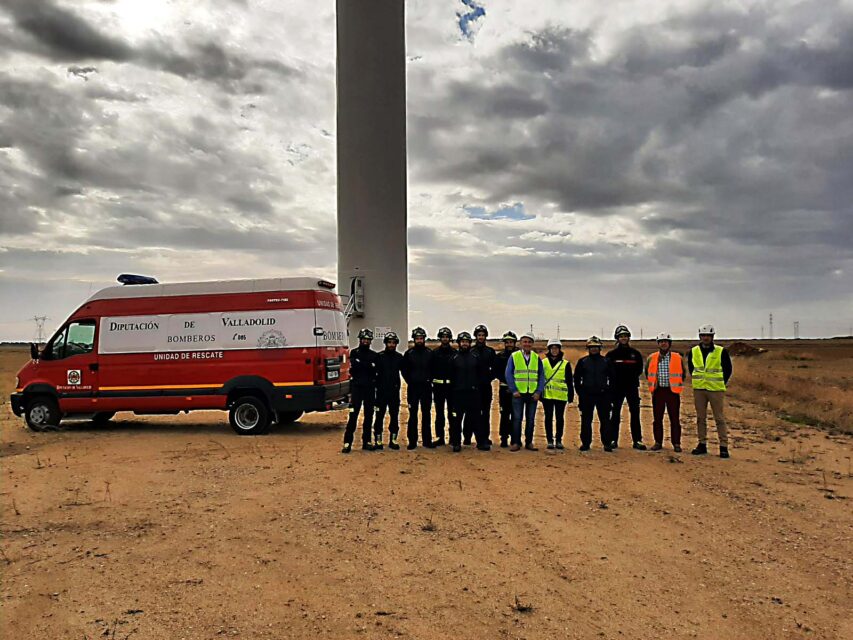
12;278;350;434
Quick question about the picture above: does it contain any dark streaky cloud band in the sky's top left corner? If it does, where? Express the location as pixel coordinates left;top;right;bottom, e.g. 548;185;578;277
0;0;299;93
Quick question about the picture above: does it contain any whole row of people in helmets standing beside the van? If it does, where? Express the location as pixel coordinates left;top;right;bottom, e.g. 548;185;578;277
343;325;732;458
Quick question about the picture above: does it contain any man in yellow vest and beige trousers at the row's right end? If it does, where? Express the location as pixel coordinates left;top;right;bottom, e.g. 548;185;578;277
687;324;732;458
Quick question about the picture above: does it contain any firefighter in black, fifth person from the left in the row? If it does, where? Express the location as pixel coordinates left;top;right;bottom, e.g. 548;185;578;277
450;331;489;453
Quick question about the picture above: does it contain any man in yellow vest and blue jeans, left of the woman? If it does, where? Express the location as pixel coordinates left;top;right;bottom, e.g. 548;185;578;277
505;333;545;451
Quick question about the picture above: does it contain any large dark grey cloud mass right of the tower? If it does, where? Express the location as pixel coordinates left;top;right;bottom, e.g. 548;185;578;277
410;1;853;269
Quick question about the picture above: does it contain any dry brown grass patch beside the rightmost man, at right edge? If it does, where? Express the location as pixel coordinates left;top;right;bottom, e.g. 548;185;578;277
732;353;853;434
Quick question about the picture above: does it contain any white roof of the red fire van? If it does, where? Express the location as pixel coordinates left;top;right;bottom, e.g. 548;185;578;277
87;278;334;302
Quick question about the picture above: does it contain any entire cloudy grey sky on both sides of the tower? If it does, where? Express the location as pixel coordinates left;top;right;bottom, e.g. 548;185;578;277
0;0;853;339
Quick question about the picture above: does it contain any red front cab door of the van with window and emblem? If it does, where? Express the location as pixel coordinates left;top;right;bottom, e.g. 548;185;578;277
40;319;98;414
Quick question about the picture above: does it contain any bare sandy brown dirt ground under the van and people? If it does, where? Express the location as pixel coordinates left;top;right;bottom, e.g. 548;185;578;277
0;347;853;640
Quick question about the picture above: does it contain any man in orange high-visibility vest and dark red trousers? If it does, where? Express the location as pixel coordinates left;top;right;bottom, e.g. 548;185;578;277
646;333;684;453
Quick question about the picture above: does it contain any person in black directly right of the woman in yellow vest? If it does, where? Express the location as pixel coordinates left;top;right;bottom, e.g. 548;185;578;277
574;336;613;451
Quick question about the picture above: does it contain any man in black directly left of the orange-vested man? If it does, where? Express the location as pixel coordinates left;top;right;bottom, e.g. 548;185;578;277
606;324;646;451
